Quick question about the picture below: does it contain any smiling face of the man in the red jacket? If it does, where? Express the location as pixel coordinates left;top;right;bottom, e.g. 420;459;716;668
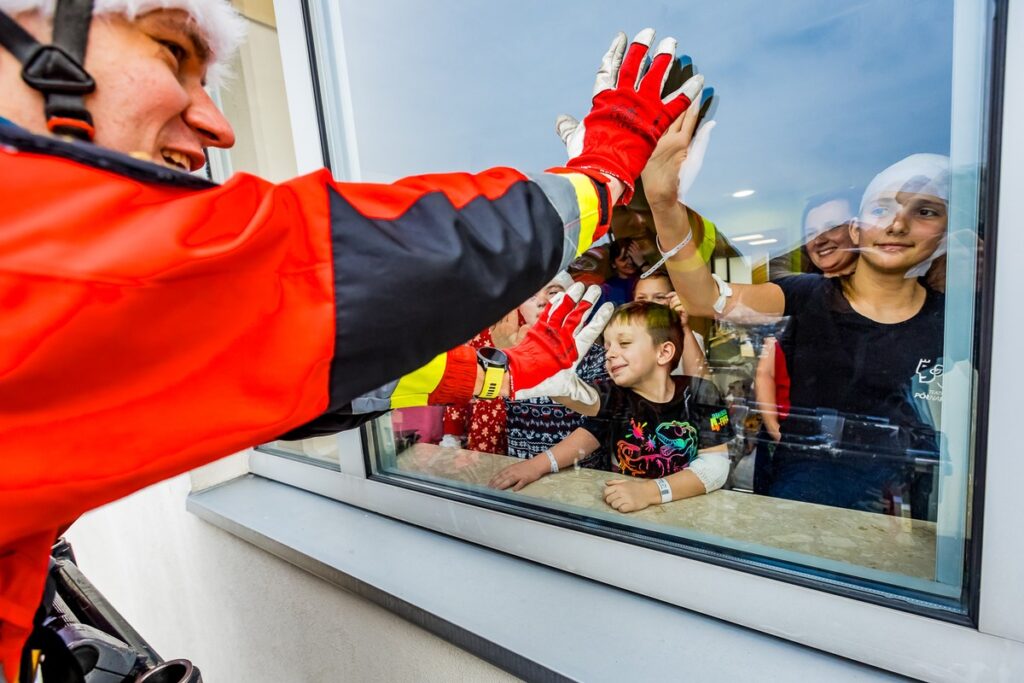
0;9;234;171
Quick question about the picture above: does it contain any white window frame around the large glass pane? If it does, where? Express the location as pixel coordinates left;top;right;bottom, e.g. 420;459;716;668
256;0;1024;680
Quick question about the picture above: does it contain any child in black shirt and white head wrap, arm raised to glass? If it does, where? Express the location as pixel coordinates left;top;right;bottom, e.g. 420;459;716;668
643;100;949;516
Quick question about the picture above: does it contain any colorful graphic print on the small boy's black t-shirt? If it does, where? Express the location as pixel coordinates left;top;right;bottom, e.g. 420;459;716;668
613;420;697;479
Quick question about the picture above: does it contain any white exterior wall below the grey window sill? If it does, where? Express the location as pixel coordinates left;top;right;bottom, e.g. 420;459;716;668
67;458;516;683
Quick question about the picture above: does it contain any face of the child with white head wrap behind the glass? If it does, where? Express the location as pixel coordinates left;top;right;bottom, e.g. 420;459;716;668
850;193;948;272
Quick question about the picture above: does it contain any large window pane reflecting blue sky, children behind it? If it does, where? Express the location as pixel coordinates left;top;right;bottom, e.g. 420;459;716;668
326;0;992;612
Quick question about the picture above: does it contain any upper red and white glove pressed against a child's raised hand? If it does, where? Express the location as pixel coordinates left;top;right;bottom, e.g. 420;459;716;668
555;29;703;204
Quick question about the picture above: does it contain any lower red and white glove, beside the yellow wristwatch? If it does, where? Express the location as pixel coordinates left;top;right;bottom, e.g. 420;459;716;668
505;283;614;403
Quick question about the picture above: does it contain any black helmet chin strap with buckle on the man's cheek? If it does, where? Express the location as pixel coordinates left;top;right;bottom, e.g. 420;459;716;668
0;0;96;141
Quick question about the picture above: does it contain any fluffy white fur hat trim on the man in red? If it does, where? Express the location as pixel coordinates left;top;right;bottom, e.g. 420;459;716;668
0;0;246;85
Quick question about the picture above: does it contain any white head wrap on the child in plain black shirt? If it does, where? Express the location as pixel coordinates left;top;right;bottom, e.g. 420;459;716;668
860;154;949;278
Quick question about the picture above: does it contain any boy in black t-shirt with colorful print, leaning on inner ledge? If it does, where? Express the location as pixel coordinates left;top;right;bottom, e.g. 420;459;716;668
489;301;732;512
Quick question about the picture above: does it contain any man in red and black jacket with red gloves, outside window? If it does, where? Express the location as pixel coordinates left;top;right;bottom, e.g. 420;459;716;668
0;0;700;680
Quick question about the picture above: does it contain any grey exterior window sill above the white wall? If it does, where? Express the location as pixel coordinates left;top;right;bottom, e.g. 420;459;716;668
187;475;903;681
